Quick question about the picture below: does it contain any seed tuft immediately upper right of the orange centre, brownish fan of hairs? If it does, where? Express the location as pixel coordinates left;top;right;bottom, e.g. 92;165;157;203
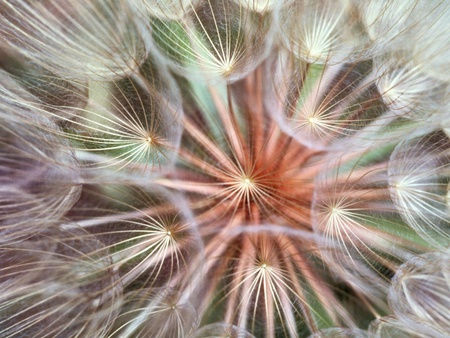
273;52;395;149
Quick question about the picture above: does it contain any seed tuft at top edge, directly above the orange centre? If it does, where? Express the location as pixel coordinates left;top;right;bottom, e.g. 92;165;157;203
151;0;273;81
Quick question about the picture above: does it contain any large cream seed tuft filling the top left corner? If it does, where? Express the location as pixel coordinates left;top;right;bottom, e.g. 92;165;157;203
0;0;147;80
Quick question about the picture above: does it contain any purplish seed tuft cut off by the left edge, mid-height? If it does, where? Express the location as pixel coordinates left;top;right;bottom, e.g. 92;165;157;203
0;77;81;242
